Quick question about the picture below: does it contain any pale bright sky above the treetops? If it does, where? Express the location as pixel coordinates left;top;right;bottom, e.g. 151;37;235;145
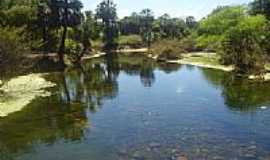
81;0;252;20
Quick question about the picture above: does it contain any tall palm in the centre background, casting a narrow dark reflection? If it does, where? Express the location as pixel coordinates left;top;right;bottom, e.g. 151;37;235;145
140;9;154;48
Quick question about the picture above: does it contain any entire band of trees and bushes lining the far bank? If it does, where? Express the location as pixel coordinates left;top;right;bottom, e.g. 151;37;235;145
0;0;270;74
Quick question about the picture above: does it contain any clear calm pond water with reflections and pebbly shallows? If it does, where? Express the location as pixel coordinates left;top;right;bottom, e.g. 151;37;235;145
0;57;270;160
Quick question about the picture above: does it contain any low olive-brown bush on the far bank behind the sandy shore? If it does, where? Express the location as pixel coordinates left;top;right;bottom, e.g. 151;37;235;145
118;35;143;48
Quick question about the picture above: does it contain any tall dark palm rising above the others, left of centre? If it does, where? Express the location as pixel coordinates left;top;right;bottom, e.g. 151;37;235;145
96;0;118;49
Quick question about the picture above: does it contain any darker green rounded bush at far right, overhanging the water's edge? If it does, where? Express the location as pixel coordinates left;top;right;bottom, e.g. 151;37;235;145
221;16;269;74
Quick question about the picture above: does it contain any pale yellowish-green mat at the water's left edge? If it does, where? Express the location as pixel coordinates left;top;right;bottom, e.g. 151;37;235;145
0;74;55;117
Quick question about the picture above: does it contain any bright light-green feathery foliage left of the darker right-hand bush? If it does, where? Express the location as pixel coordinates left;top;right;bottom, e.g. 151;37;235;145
197;6;246;50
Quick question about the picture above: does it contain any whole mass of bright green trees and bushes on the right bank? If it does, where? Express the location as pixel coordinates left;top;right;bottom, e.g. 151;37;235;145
196;0;270;74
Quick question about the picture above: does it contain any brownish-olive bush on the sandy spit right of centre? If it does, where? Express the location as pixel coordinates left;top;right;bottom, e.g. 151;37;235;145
150;40;186;60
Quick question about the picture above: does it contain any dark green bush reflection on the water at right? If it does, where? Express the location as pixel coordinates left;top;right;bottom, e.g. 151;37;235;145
201;69;270;112
